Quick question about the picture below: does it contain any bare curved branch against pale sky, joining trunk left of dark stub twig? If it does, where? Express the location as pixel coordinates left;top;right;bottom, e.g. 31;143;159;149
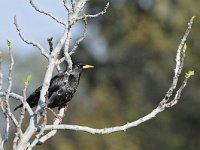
14;16;49;59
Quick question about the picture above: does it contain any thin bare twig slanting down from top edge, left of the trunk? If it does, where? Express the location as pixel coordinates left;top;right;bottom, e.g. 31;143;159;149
29;0;66;26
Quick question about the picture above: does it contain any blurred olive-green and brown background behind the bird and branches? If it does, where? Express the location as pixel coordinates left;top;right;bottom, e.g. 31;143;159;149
1;0;200;150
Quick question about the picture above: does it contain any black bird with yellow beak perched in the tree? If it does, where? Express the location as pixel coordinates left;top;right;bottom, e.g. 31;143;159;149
14;63;94;111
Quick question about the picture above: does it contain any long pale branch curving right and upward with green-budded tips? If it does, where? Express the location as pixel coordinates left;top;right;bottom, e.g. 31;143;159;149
42;18;194;136
